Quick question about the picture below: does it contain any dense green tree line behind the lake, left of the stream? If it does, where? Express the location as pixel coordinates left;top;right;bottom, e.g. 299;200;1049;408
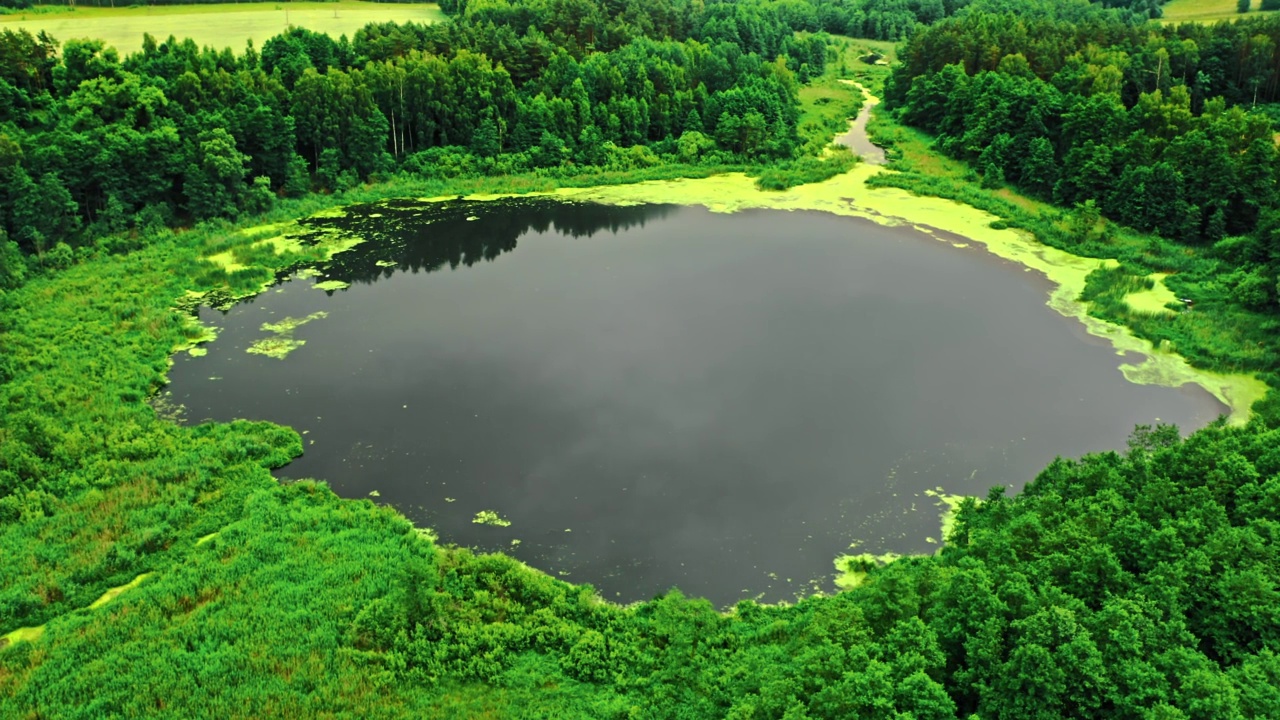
0;3;827;286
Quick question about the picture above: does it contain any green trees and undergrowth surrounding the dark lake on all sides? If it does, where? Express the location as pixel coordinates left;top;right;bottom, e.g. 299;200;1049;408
0;0;1280;720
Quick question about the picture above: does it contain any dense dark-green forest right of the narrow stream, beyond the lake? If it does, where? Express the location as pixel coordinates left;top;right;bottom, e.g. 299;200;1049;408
886;13;1280;310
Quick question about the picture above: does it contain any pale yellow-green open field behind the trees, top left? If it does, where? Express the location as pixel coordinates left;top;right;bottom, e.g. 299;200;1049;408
0;0;444;55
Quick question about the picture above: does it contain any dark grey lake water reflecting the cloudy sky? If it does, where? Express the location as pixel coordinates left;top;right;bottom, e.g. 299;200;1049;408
170;194;1224;605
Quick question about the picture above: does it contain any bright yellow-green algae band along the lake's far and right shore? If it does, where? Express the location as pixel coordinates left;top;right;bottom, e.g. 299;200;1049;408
424;164;1267;424
